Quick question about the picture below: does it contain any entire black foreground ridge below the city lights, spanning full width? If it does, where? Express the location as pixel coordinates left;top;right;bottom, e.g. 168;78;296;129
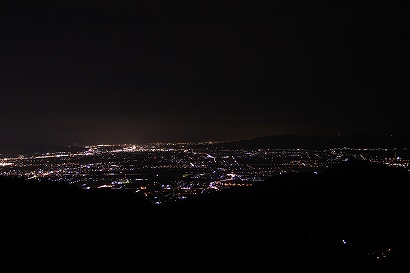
0;160;410;272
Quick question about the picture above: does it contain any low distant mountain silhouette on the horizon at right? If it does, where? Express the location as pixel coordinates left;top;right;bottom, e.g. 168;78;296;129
214;135;410;149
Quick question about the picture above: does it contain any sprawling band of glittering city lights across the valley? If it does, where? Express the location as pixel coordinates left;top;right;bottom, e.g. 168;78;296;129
0;143;410;204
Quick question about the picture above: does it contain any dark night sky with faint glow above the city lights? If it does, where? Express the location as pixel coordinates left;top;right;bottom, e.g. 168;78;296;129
0;0;410;144
